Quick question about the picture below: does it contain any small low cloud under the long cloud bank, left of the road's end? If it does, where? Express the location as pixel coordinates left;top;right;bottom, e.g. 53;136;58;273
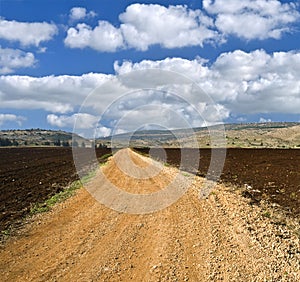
47;113;99;129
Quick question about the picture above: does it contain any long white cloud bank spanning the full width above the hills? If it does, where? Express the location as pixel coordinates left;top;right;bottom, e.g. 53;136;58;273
0;50;300;133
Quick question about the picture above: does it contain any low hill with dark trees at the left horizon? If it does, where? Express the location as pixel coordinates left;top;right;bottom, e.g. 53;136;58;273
0;128;85;146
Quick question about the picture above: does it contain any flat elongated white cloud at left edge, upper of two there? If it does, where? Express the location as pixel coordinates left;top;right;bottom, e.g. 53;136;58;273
0;18;58;47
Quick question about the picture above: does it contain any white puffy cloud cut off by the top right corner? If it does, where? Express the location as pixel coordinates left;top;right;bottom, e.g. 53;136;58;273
203;0;300;40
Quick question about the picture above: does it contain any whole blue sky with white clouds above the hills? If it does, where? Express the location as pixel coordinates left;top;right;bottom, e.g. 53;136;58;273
0;0;300;136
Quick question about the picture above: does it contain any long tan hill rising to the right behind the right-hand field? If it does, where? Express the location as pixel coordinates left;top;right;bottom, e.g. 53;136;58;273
98;122;300;148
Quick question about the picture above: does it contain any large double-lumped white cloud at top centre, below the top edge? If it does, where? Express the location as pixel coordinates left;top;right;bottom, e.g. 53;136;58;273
65;4;220;52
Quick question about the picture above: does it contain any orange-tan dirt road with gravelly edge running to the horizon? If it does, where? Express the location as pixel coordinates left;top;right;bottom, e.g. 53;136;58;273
0;150;300;281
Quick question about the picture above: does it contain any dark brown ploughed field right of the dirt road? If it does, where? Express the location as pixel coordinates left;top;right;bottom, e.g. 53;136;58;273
137;149;300;215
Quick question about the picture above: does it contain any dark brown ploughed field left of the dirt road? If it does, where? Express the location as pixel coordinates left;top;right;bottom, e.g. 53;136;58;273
0;147;111;231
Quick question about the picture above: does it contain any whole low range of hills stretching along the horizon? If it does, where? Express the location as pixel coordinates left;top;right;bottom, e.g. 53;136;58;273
0;122;300;148
